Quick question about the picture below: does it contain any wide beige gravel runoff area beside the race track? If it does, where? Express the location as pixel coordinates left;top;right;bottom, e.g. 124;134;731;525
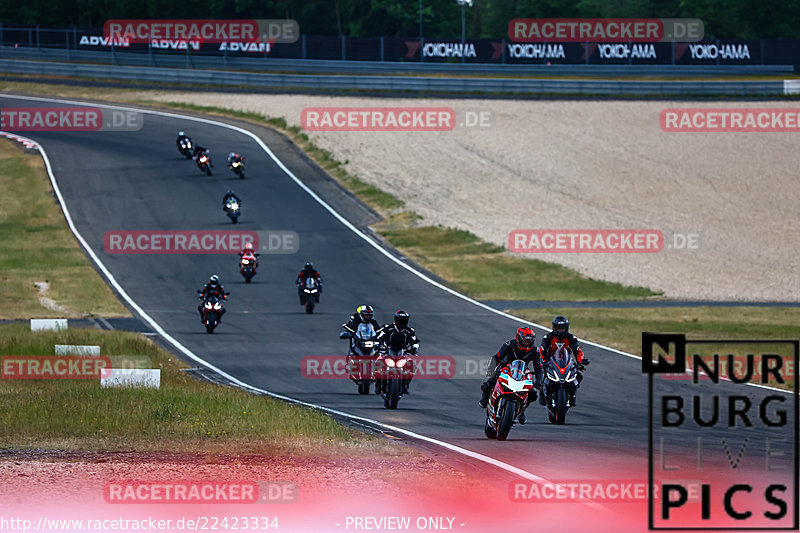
142;92;800;302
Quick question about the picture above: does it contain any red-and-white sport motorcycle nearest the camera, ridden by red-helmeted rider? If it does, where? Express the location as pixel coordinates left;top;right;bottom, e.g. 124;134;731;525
484;359;533;440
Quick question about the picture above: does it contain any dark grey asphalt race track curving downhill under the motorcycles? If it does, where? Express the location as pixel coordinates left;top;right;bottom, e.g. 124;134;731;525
0;92;792;528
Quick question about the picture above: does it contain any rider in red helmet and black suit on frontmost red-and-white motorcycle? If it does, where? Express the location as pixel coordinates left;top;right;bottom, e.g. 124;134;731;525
478;326;543;424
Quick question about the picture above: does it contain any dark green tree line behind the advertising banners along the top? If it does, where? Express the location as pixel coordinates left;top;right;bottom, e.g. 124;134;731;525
0;0;800;38
